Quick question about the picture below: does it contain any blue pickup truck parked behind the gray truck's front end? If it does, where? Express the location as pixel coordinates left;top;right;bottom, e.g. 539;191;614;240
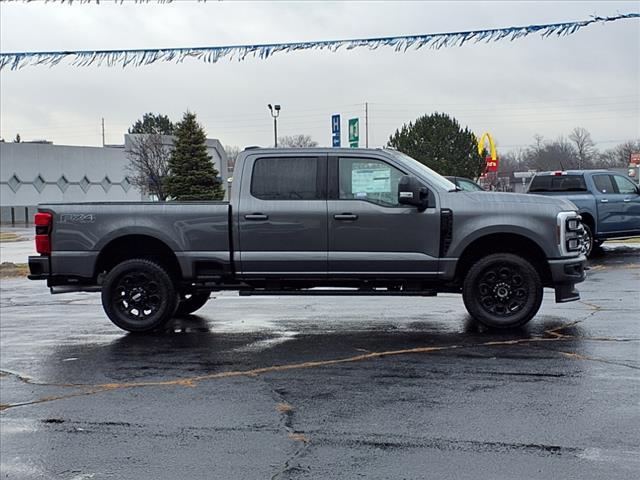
528;170;640;256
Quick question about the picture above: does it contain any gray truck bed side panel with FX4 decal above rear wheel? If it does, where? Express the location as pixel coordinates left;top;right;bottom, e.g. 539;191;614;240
39;202;232;284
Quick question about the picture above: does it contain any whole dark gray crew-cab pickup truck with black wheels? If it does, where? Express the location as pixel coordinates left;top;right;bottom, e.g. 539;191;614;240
29;149;585;332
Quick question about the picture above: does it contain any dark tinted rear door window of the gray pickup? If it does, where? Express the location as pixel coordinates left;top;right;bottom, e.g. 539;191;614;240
251;157;322;200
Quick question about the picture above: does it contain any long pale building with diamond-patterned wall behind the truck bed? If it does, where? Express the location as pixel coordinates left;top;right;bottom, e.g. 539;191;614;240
0;135;228;224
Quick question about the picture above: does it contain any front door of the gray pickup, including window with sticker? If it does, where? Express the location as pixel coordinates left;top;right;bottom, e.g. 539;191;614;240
328;154;440;278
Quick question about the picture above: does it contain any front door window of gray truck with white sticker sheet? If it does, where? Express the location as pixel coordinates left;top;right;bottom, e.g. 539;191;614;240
338;158;404;207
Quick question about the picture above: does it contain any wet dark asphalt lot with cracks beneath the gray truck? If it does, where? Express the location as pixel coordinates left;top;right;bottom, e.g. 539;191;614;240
0;246;640;480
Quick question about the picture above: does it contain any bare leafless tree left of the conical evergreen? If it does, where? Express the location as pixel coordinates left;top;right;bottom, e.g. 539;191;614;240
126;134;171;202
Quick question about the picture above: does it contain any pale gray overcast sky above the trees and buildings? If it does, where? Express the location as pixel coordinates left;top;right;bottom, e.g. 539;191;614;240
0;0;640;151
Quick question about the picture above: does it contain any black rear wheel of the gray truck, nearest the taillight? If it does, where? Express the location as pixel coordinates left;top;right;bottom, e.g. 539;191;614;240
102;259;178;332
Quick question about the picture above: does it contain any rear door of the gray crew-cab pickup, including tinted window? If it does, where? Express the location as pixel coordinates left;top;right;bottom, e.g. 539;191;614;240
236;153;327;276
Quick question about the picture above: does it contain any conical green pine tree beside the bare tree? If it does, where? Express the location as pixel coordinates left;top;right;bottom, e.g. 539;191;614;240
165;112;224;200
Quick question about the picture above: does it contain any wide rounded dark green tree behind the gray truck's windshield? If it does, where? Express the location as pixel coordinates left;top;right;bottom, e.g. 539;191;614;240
389;113;485;178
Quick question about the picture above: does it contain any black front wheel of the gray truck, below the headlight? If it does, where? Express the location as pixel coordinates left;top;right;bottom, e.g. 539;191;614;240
462;253;542;329
